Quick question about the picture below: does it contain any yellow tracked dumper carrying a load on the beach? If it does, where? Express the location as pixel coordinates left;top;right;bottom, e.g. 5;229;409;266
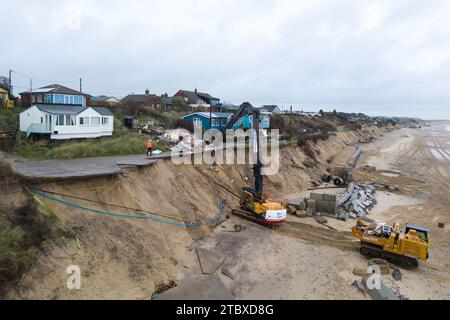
352;220;429;269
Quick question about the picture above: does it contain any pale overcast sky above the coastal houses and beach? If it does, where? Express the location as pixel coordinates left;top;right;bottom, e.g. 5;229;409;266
0;0;450;118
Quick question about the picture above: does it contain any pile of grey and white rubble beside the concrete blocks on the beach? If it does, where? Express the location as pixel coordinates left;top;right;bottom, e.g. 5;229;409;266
336;182;377;220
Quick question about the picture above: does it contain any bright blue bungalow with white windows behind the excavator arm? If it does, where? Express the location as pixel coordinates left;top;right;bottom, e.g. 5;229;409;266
182;112;270;130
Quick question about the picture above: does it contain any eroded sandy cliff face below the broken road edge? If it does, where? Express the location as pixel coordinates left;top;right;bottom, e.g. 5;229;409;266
2;127;387;299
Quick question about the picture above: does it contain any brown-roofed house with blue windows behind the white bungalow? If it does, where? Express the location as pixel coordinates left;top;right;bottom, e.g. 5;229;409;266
20;84;92;107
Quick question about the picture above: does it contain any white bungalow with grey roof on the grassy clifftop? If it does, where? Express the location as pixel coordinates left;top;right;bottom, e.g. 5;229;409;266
19;104;114;140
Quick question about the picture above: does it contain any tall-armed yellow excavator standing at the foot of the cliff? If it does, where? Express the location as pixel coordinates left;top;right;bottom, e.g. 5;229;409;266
223;102;287;227
